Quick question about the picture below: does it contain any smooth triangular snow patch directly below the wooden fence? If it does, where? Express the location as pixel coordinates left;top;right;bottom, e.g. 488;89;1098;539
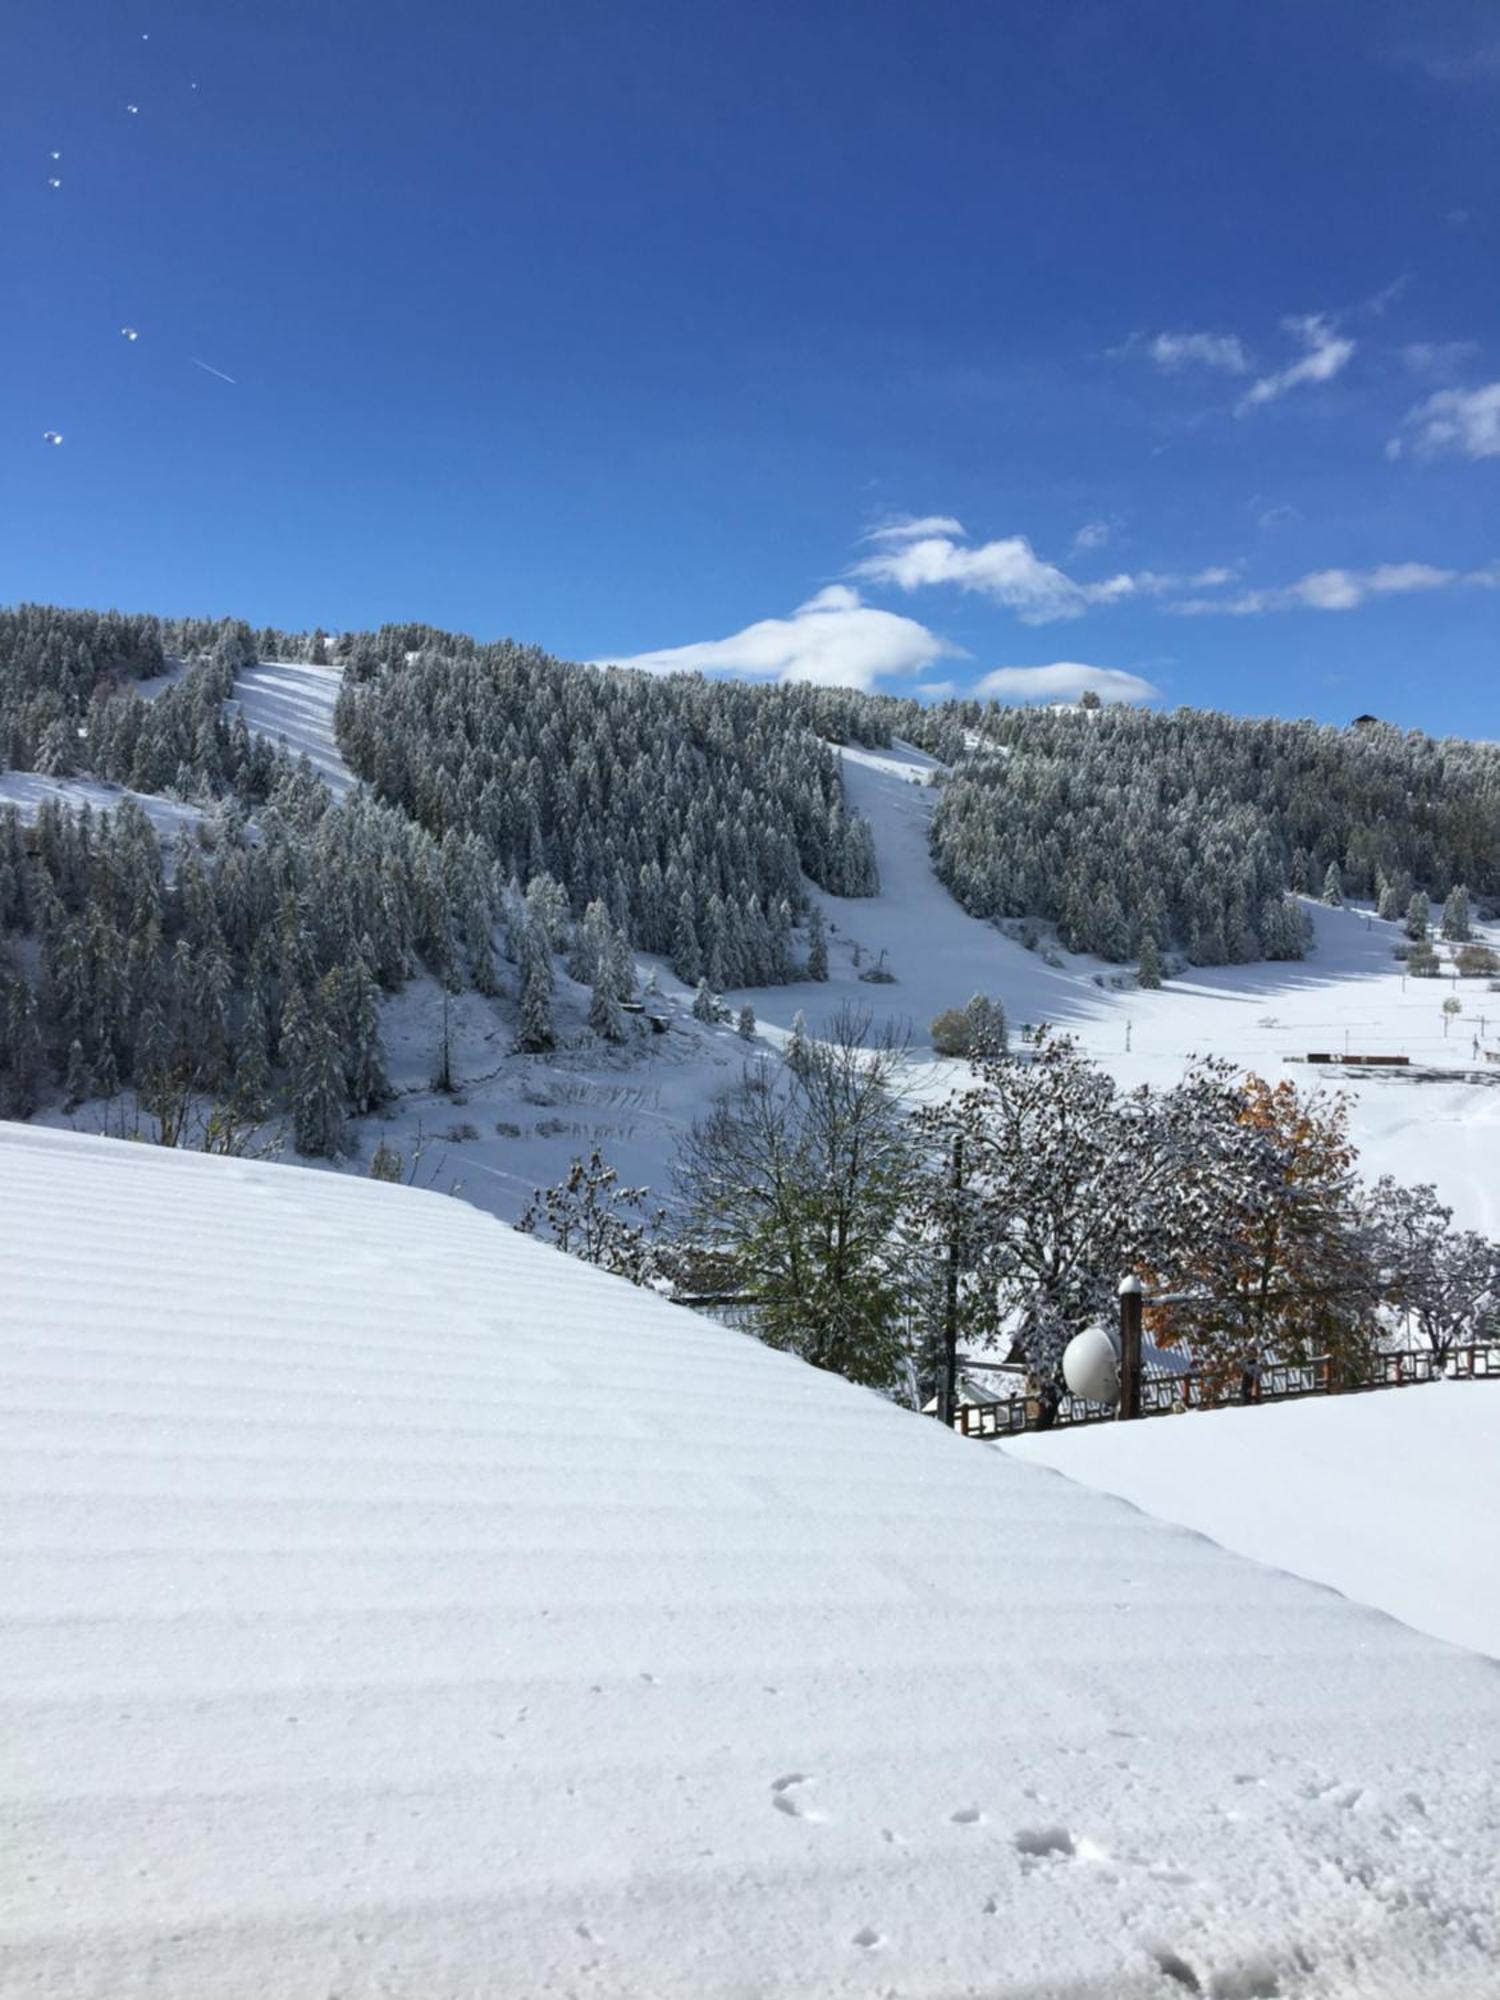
1006;1382;1500;1660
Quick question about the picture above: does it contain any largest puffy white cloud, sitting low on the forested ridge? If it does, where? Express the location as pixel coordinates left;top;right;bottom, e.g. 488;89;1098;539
592;584;960;690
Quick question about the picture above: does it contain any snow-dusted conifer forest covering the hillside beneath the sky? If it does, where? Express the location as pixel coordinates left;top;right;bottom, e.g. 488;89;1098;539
0;606;1500;1152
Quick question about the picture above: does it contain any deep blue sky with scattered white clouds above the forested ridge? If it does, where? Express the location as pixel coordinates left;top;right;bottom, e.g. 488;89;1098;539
0;0;1500;734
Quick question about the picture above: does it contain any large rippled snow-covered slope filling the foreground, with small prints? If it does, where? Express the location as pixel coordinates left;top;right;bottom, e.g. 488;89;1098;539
0;1126;1500;2000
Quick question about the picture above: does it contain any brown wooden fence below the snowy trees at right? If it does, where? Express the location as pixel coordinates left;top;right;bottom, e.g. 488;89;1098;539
954;1340;1500;1438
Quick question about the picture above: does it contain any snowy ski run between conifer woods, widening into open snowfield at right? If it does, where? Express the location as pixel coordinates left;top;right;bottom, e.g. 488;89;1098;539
744;744;1500;1236
